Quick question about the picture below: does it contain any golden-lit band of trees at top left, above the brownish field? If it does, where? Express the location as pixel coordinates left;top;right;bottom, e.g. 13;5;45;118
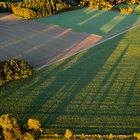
0;0;70;19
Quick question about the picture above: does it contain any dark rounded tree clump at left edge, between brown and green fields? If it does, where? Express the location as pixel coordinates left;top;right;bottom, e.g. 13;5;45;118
0;59;32;85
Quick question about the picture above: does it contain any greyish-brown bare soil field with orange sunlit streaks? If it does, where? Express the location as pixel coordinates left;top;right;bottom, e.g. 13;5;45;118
0;14;102;67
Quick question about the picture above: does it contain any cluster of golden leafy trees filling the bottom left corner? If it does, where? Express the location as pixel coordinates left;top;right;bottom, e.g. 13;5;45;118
0;114;42;140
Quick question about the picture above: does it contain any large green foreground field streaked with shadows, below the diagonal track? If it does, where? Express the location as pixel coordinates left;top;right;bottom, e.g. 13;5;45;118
0;23;140;134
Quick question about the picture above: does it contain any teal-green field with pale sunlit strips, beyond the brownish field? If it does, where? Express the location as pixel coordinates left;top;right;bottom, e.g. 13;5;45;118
35;8;140;36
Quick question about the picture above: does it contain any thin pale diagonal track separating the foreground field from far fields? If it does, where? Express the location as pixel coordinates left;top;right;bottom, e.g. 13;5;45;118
37;23;140;71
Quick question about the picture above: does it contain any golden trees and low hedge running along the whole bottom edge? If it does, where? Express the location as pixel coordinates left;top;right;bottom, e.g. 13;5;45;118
0;114;140;140
